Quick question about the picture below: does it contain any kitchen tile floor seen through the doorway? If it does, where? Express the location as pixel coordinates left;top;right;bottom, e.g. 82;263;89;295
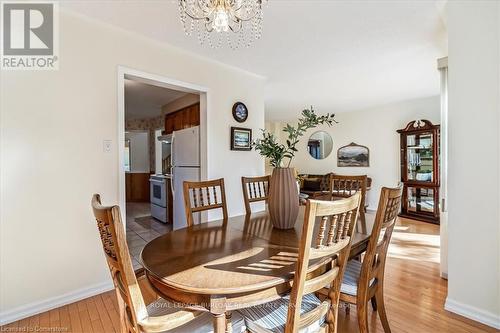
127;202;172;269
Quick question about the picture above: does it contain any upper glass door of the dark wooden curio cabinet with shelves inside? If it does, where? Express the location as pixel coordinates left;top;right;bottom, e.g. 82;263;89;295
406;132;434;182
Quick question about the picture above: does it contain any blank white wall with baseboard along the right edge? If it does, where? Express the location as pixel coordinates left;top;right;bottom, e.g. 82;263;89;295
446;1;500;328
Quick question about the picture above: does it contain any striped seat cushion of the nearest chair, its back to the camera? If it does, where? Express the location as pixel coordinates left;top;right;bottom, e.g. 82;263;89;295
239;294;326;333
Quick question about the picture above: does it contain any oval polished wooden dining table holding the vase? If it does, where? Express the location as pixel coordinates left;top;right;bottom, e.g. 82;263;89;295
141;207;374;333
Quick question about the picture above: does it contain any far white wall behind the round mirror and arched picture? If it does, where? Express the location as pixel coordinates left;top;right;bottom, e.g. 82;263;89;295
266;96;440;209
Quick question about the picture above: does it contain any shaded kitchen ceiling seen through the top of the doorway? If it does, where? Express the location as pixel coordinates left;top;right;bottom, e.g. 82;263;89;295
125;80;187;120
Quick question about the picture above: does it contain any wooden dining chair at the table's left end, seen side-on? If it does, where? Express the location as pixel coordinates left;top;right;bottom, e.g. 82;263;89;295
92;194;232;333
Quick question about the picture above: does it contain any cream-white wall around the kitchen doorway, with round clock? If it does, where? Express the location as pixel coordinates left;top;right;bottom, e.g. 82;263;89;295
0;12;264;320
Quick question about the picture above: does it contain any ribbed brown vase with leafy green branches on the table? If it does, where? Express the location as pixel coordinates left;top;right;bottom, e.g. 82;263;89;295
254;106;337;229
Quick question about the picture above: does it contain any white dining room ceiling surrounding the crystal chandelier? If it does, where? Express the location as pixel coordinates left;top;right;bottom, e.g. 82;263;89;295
63;0;447;120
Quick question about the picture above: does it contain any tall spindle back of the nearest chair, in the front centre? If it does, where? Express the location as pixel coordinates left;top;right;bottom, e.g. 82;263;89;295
285;193;361;333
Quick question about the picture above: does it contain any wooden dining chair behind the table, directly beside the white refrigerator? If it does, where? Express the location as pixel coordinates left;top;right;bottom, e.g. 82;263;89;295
184;178;227;227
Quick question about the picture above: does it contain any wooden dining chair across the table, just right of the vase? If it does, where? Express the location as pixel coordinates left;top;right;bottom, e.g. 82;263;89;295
330;173;368;233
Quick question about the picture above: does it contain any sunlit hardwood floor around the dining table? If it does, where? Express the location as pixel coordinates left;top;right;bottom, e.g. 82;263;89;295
0;219;498;333
